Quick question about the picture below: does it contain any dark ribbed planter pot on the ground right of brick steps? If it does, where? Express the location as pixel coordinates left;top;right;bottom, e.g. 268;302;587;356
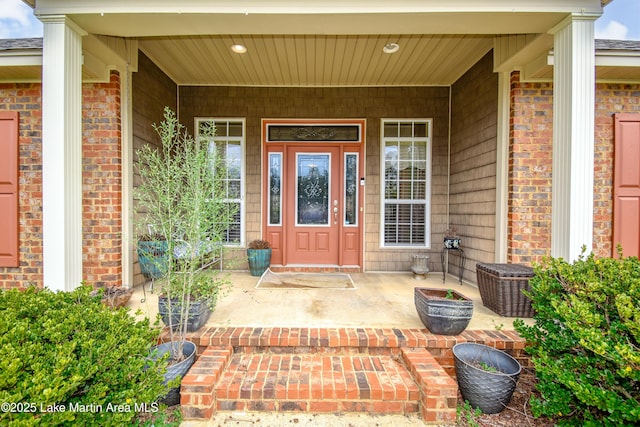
453;343;522;414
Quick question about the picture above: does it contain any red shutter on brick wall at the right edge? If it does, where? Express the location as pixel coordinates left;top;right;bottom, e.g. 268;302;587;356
613;114;640;256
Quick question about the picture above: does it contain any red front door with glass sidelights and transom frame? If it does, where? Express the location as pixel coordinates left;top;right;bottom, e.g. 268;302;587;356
262;120;364;269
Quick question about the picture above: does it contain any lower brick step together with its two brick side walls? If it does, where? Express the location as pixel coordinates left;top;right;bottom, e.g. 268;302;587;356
181;347;457;423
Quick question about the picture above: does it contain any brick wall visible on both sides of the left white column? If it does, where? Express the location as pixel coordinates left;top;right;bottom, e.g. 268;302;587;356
0;72;122;288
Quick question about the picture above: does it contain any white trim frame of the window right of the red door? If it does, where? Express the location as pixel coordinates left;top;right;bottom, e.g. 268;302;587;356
379;118;433;250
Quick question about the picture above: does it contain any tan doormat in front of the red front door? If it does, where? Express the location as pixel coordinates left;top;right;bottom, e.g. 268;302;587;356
256;269;356;289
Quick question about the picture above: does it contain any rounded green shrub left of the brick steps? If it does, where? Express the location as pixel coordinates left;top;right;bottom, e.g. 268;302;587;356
0;286;166;426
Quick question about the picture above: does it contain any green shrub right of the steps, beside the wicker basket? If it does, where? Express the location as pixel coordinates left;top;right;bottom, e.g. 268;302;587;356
515;253;640;426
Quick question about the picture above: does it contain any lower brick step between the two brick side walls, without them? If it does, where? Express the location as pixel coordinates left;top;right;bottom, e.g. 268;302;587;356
216;353;420;414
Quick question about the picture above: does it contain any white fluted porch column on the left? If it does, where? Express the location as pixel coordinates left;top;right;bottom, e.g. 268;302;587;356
40;16;86;290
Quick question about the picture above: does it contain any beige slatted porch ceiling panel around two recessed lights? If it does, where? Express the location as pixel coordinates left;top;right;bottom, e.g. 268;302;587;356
140;34;493;86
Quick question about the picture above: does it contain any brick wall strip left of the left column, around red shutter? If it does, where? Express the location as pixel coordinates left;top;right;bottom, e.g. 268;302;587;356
0;83;42;288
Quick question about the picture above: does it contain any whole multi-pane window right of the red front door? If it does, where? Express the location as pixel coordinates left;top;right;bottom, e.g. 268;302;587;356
380;119;432;247
